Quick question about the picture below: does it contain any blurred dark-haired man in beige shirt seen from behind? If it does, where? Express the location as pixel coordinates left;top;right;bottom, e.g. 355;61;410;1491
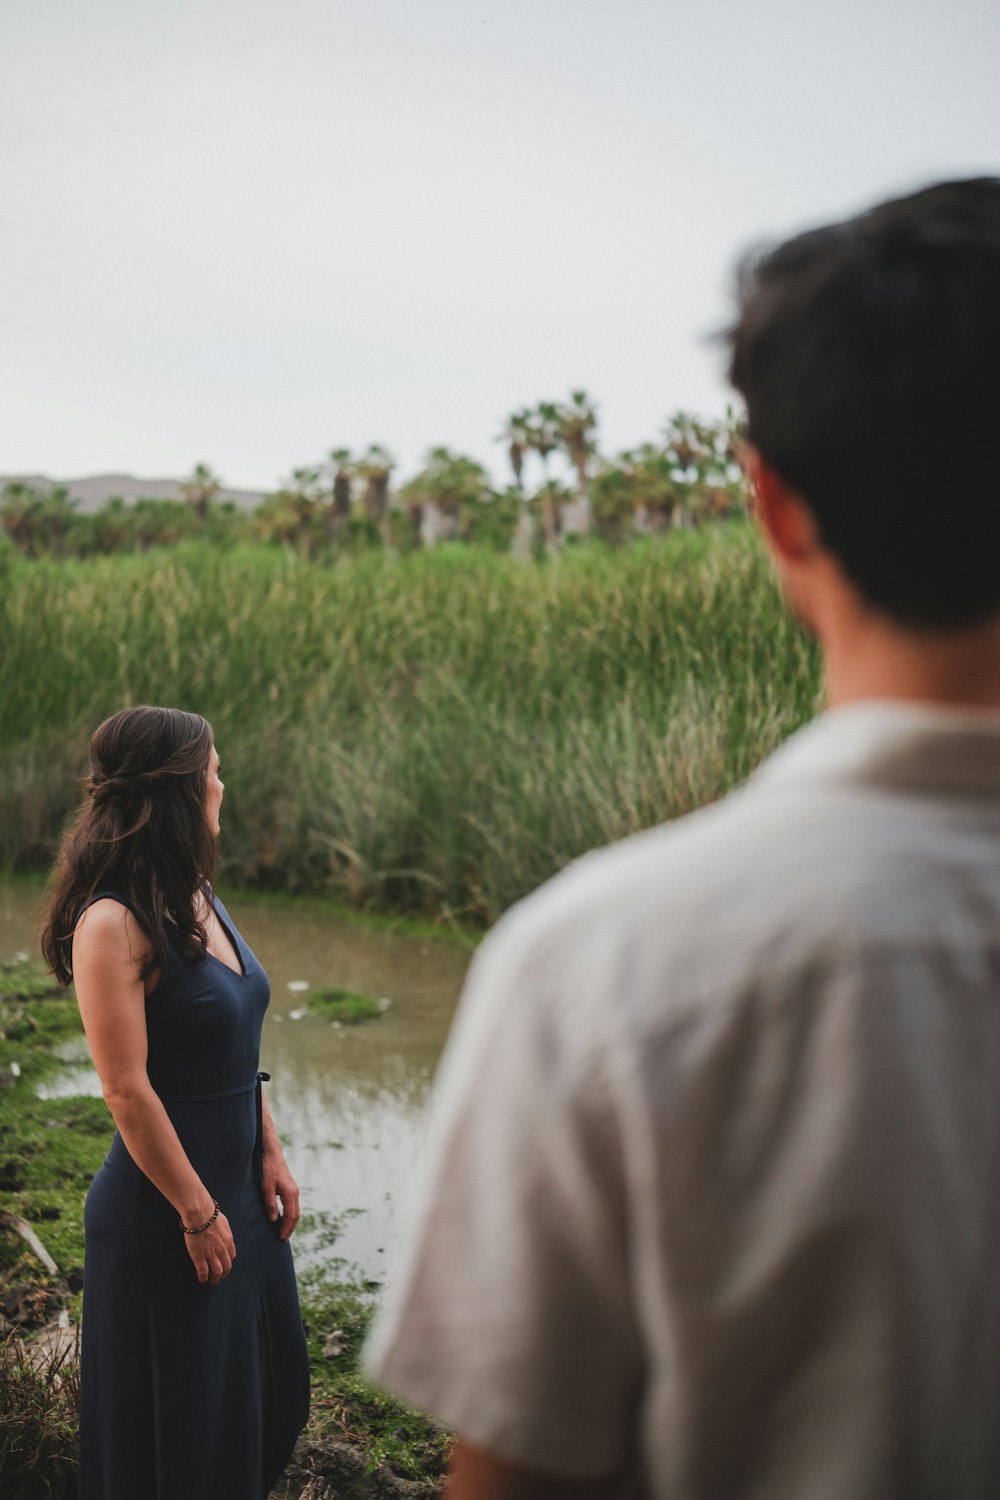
369;180;1000;1500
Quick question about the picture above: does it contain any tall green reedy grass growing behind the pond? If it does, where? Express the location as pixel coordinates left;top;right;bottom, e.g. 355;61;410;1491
0;524;819;921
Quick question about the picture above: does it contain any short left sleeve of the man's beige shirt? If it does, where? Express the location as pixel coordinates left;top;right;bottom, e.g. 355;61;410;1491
366;900;639;1478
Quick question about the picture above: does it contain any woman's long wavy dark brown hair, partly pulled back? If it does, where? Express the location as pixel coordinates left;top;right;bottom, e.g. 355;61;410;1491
40;708;216;984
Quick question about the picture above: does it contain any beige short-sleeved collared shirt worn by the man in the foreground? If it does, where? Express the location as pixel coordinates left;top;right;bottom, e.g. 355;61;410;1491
367;704;1000;1500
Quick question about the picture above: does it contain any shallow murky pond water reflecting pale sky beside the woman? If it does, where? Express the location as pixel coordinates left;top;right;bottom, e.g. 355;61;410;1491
0;884;469;1281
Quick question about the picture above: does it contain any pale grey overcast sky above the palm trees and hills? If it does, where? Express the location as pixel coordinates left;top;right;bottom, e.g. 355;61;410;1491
0;0;1000;488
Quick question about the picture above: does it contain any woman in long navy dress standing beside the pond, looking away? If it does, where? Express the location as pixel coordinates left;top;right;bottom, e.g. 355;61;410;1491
42;708;309;1500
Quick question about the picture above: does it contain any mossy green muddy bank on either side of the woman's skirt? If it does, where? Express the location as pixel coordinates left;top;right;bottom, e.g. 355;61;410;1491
0;963;448;1500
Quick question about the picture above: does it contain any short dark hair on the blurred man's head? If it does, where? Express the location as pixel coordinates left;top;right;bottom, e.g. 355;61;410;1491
729;177;1000;629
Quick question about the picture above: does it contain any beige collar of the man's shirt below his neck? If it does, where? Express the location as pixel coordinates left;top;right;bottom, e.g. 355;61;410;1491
754;699;1000;797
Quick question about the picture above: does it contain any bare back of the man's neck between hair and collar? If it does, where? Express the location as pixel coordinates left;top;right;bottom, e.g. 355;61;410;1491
823;611;1000;708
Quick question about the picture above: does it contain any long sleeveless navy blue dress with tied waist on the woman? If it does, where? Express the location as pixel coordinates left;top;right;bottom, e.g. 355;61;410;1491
79;891;309;1500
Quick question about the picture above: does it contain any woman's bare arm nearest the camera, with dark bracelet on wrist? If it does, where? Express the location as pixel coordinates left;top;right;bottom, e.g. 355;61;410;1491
73;900;235;1286
